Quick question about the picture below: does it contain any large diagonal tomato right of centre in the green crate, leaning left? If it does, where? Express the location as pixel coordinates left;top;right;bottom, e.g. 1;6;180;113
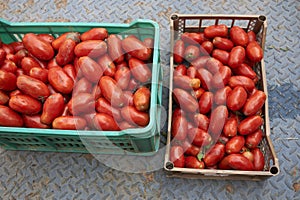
99;76;125;107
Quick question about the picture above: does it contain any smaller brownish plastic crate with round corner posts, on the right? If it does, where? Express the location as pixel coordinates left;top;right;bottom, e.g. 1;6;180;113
164;14;279;180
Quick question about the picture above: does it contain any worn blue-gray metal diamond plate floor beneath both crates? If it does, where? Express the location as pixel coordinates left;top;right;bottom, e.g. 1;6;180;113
0;0;300;199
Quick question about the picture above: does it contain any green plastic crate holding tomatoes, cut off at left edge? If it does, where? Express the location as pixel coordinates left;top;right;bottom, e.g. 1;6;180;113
0;19;162;156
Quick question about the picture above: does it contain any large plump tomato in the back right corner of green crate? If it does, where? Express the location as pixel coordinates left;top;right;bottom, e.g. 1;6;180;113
121;37;152;61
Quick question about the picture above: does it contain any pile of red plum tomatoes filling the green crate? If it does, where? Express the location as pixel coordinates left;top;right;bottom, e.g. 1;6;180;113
0;27;153;131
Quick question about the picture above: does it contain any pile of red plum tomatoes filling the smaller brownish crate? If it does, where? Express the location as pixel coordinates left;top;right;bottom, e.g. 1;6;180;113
170;24;266;171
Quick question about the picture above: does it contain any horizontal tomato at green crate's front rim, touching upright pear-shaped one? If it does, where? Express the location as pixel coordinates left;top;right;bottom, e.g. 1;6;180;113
52;116;86;130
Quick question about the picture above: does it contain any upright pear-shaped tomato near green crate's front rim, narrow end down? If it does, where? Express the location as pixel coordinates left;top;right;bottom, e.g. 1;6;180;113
40;93;65;125
